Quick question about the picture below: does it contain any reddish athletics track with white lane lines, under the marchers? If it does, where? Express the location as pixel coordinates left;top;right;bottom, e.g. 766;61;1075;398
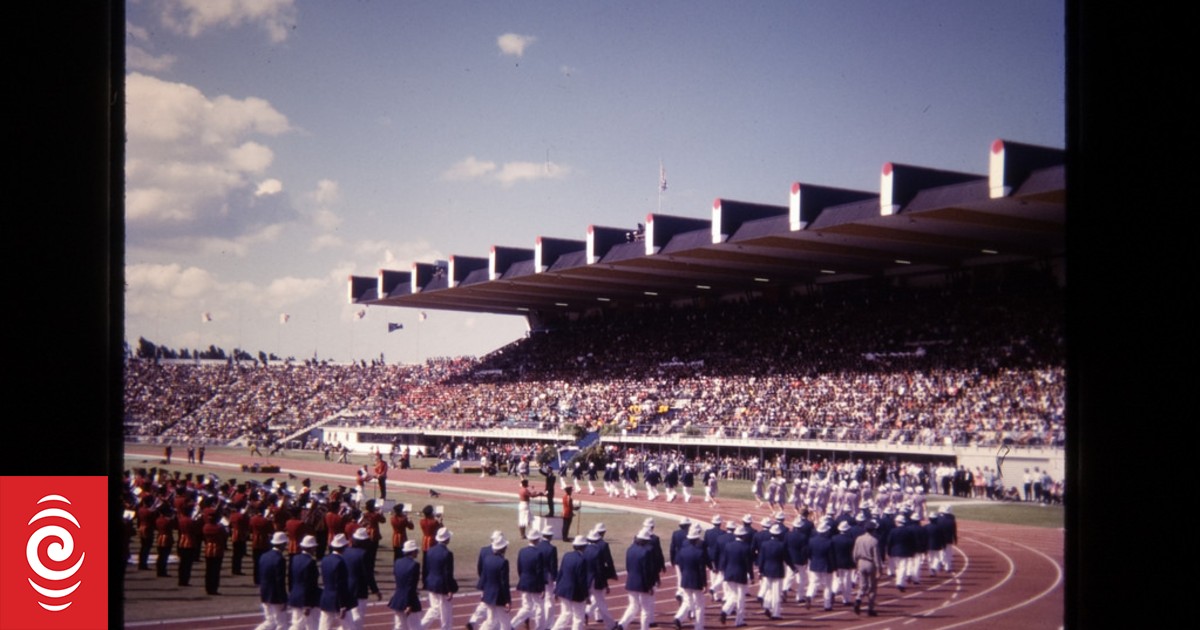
119;445;1064;630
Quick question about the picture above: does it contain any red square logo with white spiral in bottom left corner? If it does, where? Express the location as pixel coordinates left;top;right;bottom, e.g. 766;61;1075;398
0;476;108;630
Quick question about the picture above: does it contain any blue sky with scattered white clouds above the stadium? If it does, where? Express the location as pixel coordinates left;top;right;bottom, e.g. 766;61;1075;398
126;0;1066;362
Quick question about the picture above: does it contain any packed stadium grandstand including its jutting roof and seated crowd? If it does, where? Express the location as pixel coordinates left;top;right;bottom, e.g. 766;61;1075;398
125;140;1067;479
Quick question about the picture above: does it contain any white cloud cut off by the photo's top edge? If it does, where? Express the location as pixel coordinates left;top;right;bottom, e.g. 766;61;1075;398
162;0;296;43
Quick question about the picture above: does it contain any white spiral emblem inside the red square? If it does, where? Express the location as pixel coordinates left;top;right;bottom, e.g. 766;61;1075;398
25;494;86;612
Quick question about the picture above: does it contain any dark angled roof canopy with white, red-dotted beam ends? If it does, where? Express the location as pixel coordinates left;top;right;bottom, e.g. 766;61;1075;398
349;139;1067;314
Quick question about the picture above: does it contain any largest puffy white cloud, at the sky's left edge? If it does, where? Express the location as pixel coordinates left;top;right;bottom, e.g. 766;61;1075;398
125;72;289;227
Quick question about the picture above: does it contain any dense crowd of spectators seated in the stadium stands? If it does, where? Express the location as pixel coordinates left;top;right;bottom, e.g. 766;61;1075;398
125;278;1066;446
